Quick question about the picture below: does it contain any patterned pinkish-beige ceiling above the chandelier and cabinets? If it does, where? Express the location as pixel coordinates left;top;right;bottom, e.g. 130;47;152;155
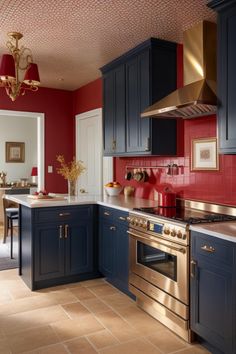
0;0;216;90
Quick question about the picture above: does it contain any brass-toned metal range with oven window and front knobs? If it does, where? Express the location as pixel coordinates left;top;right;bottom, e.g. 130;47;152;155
128;207;236;342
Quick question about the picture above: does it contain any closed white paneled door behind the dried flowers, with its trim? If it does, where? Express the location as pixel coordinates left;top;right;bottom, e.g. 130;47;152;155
76;108;103;195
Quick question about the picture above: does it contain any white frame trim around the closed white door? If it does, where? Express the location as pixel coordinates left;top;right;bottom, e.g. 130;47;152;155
75;108;103;194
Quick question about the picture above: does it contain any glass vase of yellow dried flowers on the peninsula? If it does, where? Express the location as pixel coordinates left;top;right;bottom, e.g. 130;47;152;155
57;155;86;196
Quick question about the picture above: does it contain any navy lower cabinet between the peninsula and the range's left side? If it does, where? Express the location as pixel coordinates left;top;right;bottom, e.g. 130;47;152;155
99;207;132;296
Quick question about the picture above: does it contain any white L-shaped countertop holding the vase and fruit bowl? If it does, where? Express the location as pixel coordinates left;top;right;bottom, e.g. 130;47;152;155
6;194;157;211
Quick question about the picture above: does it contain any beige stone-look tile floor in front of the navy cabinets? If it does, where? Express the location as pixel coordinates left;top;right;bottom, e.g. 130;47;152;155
0;269;209;354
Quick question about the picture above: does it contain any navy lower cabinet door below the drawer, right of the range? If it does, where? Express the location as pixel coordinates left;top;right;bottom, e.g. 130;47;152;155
191;260;233;353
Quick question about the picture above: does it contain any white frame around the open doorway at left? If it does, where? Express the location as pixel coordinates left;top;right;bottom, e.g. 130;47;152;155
0;109;45;190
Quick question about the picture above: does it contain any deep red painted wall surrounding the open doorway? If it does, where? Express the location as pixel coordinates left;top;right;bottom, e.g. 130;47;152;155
0;87;74;192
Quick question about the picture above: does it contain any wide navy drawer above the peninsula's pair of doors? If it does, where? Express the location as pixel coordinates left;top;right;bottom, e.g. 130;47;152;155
35;207;91;223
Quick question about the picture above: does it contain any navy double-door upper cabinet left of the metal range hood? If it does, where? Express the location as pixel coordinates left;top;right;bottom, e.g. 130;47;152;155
101;38;177;156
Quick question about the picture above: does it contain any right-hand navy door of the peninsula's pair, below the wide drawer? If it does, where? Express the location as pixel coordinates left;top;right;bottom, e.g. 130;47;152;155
65;220;94;275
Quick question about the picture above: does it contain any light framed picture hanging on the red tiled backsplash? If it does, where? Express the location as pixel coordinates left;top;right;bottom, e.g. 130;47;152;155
191;138;219;171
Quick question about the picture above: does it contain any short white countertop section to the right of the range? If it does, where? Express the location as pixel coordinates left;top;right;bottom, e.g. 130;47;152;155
190;221;236;242
